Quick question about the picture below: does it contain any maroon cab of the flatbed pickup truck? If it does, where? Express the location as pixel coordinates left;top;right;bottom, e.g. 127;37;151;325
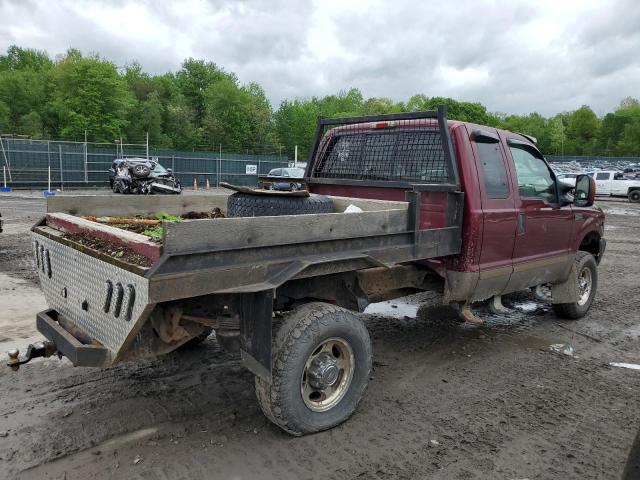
307;114;605;302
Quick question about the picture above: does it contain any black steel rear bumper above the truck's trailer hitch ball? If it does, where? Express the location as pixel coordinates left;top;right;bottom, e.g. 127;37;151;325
36;309;110;367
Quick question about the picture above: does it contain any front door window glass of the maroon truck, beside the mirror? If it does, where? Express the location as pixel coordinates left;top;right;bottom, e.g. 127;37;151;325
510;147;556;203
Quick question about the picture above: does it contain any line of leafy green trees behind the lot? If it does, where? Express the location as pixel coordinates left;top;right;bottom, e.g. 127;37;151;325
0;46;640;158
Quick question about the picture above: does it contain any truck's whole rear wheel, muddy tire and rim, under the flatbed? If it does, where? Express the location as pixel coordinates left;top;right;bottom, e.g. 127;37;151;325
255;302;372;435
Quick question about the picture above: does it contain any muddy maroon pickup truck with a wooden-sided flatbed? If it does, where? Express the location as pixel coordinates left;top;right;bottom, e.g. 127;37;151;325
15;108;605;435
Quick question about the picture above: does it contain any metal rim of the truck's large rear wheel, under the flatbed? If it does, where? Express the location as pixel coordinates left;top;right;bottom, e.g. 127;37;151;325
300;337;355;412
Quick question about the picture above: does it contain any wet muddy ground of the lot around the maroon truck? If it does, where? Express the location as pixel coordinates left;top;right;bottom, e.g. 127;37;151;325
0;193;640;479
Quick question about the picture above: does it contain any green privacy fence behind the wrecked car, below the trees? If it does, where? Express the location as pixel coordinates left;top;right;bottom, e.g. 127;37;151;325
0;138;288;189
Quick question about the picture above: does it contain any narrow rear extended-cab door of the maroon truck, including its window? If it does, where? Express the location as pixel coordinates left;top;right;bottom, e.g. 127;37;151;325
469;128;517;298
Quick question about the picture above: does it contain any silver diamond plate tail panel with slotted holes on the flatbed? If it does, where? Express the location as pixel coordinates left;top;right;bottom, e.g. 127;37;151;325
31;233;149;360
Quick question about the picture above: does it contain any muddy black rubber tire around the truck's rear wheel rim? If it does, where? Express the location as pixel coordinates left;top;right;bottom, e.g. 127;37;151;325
255;302;372;436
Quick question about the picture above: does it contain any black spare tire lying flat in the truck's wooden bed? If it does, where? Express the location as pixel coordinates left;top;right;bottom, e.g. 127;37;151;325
227;192;335;217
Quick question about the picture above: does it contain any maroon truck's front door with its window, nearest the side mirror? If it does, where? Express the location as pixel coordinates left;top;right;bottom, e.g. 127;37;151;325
506;135;573;292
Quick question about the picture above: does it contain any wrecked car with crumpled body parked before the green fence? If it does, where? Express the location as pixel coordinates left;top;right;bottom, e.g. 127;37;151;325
109;158;182;194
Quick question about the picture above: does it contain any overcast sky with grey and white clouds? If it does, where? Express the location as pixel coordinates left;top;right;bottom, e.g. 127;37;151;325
0;0;640;115
